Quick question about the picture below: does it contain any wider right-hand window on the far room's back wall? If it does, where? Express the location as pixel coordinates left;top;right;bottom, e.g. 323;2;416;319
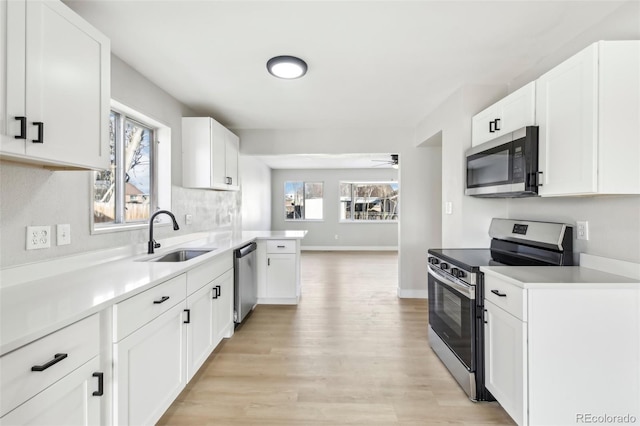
340;182;399;222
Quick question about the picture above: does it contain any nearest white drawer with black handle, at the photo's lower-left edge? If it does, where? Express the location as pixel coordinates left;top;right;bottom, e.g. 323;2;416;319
0;314;100;416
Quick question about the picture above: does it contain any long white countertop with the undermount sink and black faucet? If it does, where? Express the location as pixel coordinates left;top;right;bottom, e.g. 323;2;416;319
0;231;307;355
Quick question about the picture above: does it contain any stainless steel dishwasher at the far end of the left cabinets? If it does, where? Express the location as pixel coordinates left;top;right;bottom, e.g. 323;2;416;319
233;243;258;324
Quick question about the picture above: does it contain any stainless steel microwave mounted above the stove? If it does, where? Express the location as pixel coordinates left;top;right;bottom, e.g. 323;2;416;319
465;126;540;198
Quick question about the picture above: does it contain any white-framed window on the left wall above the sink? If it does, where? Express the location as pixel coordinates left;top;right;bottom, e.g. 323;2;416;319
92;101;171;232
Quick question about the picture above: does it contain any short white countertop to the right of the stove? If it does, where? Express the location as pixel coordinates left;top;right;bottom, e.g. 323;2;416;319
480;266;640;289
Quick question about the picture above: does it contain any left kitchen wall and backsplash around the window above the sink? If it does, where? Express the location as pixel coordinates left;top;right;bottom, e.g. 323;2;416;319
0;55;241;267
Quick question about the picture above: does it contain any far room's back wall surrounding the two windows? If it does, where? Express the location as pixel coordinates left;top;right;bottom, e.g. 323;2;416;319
271;169;403;250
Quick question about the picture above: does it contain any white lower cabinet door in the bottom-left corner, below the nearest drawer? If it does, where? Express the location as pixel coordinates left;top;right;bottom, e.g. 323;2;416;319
0;357;106;426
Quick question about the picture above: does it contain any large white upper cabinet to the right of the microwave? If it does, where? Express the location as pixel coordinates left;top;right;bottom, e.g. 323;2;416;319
536;41;640;196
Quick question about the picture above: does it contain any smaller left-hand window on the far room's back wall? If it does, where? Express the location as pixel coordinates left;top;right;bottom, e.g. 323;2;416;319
284;182;323;220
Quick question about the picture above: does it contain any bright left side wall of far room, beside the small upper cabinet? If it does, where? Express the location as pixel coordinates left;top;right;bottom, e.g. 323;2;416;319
240;155;271;231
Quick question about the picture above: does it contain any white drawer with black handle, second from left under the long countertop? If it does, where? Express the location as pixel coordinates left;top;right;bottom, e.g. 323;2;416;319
113;274;187;343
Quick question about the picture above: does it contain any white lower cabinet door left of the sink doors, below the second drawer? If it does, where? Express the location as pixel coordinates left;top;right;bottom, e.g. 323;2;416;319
114;304;187;425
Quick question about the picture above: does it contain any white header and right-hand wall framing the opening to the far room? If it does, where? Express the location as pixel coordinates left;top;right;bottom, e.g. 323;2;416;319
236;128;442;297
